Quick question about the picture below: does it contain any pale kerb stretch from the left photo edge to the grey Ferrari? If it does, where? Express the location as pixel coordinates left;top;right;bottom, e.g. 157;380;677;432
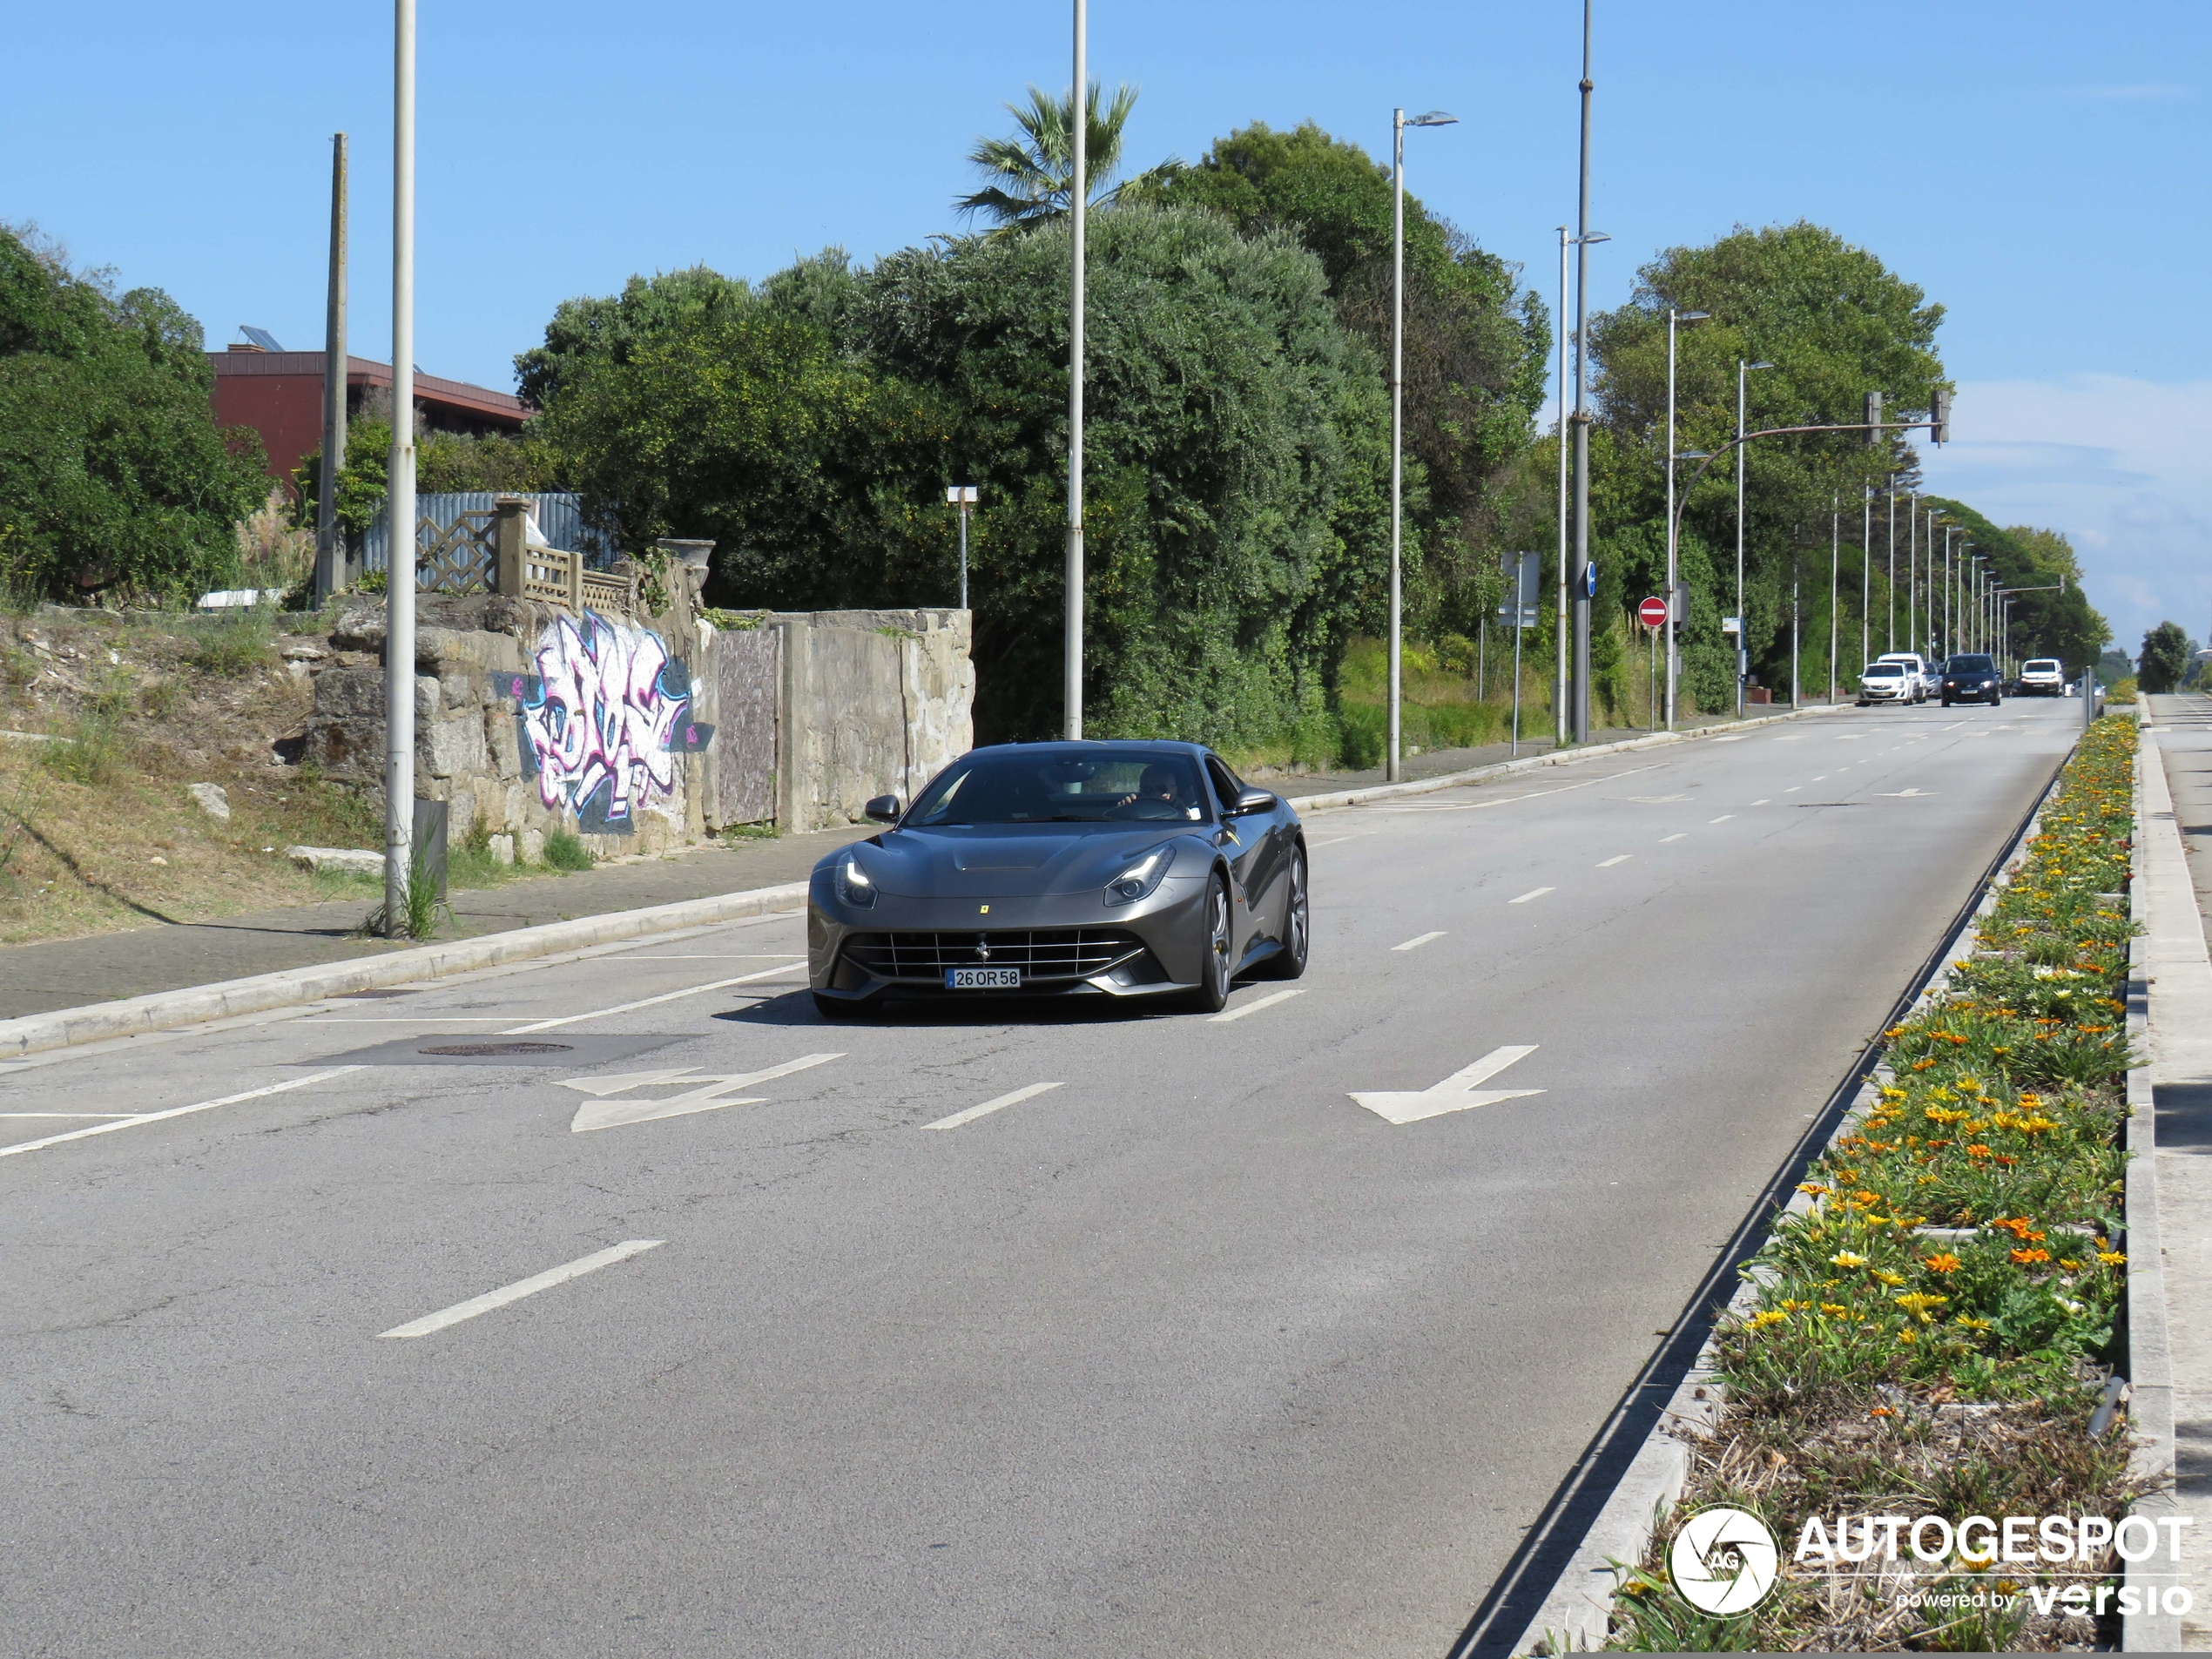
0;880;807;1060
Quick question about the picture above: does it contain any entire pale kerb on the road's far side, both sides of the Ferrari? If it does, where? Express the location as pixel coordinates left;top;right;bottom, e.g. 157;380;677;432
0;705;1827;1060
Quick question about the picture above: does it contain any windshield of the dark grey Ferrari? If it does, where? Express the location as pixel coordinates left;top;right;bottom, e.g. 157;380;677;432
905;748;1205;830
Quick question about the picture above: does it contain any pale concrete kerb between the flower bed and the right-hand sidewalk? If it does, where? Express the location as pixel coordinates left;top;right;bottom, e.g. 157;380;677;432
2119;730;2212;1652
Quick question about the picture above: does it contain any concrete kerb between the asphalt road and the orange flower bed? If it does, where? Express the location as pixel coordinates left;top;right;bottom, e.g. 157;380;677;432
1511;752;2073;1655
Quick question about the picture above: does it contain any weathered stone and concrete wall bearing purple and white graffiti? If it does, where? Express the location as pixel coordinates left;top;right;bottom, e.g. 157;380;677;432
303;579;975;856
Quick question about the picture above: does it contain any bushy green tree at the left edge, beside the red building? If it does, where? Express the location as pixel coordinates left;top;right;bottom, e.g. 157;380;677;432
0;228;267;599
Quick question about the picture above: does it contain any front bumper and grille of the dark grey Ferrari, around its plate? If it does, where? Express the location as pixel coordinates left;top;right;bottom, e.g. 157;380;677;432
807;873;1205;1002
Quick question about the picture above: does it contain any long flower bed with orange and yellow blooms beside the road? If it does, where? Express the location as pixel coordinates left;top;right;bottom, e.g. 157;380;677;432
1610;719;2137;1652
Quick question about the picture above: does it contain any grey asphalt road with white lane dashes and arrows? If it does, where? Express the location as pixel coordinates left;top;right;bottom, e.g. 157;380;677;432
0;701;2080;1659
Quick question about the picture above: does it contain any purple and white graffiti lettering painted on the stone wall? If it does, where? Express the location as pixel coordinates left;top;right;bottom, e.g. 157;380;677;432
493;610;714;836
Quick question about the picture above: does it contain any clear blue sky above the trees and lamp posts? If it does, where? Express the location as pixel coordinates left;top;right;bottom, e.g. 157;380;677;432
0;0;2212;648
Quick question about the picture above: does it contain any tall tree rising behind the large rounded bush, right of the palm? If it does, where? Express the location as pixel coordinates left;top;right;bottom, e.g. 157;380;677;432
1143;122;1551;632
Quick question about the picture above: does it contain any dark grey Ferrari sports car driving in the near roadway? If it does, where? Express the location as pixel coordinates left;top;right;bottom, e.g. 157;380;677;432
807;743;1312;1015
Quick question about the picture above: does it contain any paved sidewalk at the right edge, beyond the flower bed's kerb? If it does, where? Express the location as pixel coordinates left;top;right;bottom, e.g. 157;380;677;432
2137;697;2212;1652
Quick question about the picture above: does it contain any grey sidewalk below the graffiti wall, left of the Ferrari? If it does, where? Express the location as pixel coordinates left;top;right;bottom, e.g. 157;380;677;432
0;825;873;1020
